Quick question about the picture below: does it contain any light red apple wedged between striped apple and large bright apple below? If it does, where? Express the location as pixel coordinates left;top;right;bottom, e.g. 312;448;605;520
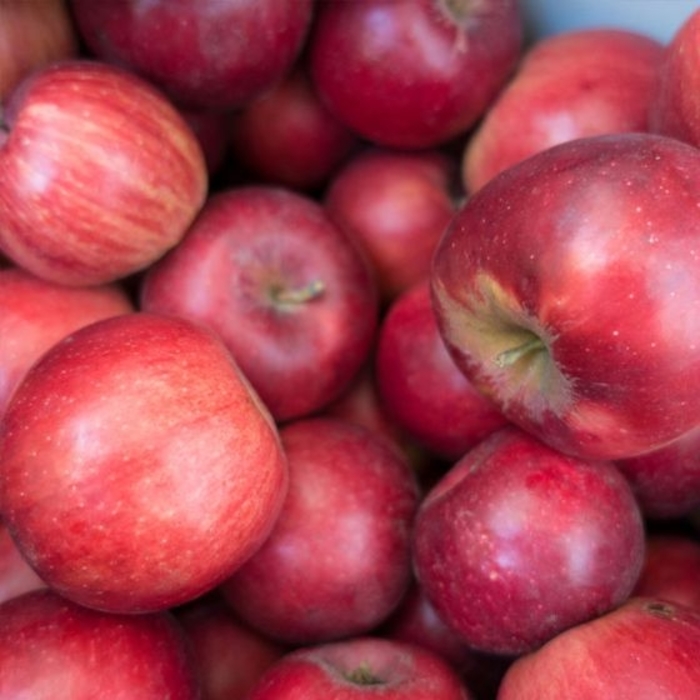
0;266;135;416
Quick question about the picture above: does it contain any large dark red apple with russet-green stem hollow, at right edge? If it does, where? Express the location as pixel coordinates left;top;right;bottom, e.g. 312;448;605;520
431;133;700;459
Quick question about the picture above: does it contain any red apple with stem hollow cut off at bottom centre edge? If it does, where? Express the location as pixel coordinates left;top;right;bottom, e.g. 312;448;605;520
247;636;472;700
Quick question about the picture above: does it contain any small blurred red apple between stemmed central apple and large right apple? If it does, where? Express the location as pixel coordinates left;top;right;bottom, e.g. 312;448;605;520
323;148;457;304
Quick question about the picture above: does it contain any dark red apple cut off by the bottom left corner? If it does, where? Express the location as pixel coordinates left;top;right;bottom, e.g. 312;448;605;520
0;589;200;700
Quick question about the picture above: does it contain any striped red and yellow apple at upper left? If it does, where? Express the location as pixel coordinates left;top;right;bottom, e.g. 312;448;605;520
0;60;208;285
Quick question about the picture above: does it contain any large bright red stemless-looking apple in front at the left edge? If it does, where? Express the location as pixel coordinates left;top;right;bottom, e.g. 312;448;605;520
0;313;287;612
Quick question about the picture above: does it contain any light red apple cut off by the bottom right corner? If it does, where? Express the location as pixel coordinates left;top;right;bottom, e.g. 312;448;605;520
498;598;700;700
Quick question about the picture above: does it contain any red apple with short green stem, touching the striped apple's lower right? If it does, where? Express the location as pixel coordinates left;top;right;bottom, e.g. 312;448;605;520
140;185;379;422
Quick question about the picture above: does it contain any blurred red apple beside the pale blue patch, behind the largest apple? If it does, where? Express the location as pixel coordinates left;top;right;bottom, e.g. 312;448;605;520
462;28;664;192
